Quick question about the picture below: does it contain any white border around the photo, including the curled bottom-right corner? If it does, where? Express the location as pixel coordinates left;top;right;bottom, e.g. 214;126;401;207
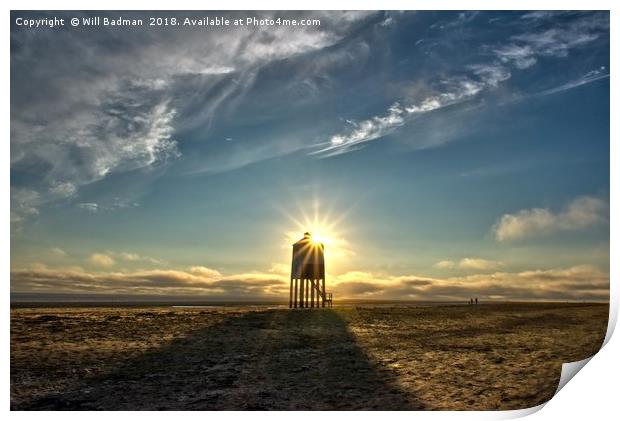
0;0;620;421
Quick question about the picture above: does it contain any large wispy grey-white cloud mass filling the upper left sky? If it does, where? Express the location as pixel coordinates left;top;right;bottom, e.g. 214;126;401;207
11;12;371;224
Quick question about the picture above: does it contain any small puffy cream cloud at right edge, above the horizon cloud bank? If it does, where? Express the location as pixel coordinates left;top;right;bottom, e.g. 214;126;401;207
493;196;609;242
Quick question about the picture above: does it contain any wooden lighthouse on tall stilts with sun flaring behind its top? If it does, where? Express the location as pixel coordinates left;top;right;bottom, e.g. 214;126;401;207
289;232;332;308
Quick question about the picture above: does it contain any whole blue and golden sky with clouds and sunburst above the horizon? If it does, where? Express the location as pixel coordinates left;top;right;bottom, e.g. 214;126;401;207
10;11;610;301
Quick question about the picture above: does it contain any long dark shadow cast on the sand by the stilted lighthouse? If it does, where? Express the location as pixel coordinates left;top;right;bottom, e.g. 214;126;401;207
18;309;423;410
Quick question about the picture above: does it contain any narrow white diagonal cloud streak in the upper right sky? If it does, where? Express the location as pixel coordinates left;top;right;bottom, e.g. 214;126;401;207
322;14;609;156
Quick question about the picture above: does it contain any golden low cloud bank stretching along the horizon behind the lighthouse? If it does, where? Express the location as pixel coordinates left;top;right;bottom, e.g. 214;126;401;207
11;265;609;302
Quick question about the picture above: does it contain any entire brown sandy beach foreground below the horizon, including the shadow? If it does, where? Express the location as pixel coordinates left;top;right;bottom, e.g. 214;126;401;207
11;304;608;410
